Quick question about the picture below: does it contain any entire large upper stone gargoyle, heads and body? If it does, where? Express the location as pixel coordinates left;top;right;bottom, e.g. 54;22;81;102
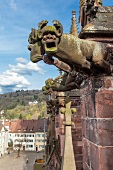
28;20;111;75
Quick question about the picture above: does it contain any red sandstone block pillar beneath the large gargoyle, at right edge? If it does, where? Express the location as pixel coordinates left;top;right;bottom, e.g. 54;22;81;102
81;76;113;170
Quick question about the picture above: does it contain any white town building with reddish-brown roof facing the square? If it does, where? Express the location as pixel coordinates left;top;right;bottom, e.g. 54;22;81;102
9;119;47;151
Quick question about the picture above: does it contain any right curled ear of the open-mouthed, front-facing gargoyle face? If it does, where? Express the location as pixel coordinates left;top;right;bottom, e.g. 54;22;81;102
52;20;63;37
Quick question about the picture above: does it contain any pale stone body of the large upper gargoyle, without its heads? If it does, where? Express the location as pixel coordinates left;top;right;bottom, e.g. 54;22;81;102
48;34;108;70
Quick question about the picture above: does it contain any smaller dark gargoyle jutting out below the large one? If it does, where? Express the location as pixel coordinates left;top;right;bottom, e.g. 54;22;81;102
42;71;84;94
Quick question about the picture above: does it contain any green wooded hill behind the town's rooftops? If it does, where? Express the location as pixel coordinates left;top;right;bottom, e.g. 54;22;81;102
0;90;48;119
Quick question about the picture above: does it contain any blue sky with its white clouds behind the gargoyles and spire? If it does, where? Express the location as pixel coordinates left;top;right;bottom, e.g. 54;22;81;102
0;0;113;93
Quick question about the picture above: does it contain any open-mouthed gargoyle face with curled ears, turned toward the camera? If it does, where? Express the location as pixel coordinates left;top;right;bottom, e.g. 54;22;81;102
38;20;63;55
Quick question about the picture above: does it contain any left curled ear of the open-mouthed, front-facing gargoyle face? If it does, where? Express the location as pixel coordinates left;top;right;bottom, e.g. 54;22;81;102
38;20;48;39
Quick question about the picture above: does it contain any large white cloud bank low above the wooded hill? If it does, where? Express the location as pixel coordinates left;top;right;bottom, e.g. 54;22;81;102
0;57;44;93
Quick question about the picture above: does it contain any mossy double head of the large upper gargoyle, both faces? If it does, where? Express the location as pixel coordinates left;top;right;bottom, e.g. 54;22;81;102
28;20;63;63
